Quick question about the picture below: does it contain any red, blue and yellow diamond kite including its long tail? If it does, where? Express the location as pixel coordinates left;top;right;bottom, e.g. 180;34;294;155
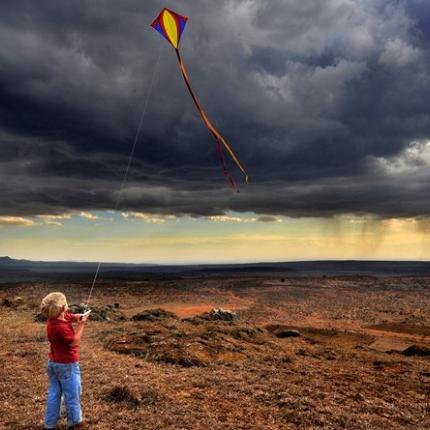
151;8;248;191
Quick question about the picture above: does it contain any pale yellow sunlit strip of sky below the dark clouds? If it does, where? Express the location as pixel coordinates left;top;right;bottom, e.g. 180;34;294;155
0;211;430;264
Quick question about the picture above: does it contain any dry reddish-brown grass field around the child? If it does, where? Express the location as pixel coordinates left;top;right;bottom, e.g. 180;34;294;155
0;276;430;430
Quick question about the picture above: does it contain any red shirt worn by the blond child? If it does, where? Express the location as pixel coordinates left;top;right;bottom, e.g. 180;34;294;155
46;313;79;363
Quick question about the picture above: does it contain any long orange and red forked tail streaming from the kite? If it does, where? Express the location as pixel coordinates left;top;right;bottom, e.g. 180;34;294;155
175;48;249;186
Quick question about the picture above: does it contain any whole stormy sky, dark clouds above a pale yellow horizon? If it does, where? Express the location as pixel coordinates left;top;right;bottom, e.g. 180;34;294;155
0;0;430;263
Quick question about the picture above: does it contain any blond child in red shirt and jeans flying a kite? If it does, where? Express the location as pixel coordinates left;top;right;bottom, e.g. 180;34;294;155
40;293;88;430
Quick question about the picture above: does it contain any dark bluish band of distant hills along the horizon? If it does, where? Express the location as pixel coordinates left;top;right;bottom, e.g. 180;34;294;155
0;257;430;279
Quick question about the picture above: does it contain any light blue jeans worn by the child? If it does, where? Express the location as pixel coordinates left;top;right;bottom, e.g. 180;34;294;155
45;360;82;429
